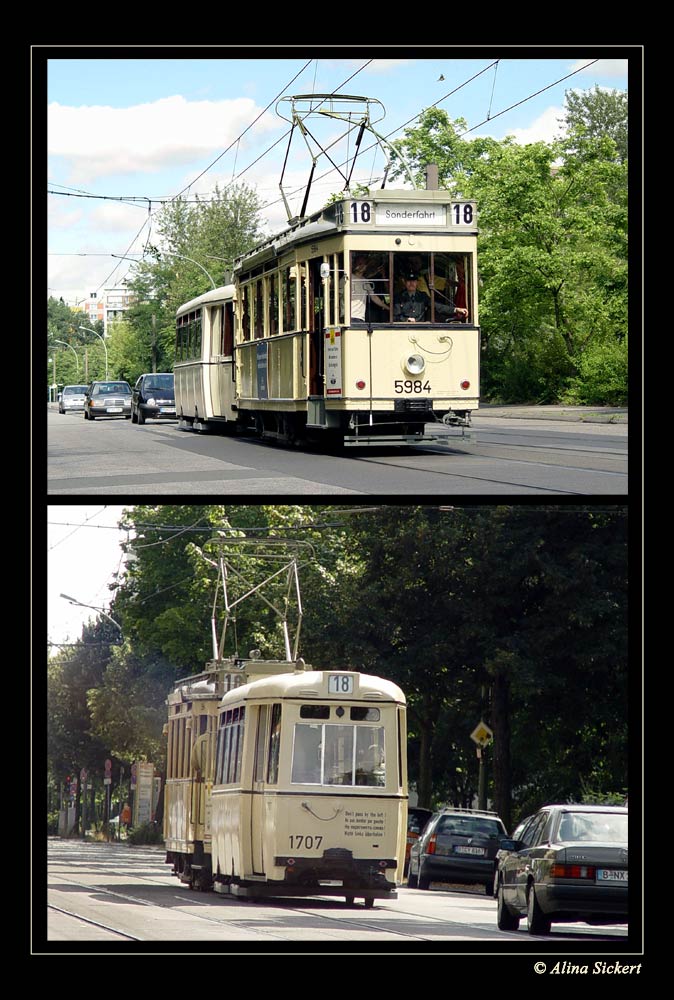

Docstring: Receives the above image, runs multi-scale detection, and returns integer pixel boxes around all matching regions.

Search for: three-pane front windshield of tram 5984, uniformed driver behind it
[350,250,470,324]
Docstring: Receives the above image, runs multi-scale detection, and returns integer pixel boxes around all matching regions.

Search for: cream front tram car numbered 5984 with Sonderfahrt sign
[234,189,480,445]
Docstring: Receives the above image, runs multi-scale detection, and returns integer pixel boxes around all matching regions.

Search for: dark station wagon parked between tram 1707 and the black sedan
[407,807,507,896]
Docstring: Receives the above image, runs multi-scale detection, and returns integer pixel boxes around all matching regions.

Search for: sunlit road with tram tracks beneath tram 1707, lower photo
[43,837,638,948]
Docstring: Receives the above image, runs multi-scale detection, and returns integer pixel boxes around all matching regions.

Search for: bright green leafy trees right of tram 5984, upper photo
[386,88,628,404]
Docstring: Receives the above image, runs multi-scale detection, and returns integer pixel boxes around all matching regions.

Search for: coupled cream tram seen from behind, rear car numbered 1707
[164,659,407,907]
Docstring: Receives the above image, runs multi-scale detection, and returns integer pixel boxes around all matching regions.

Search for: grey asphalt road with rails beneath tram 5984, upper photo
[47,404,628,497]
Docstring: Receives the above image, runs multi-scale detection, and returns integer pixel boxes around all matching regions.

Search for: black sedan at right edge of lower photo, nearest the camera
[496,805,628,934]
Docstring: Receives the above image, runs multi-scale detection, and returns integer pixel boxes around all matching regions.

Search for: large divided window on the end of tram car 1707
[291,723,386,786]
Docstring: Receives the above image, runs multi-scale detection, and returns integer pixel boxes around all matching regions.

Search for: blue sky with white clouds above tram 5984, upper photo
[46,47,627,306]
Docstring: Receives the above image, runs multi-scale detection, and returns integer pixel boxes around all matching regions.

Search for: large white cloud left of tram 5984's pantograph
[48,96,278,184]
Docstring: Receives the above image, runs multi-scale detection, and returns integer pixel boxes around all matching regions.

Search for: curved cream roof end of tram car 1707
[222,670,406,705]
